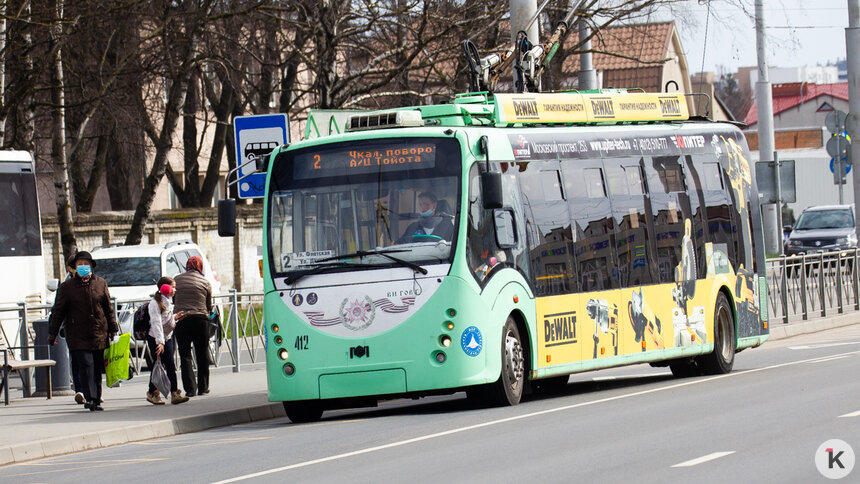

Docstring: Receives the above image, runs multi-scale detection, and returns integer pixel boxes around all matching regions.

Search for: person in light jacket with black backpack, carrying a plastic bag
[144,277,188,405]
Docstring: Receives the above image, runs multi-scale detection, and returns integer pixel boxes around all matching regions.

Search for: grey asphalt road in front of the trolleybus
[0,325,860,484]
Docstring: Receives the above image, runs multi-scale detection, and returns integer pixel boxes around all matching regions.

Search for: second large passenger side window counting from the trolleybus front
[561,160,619,291]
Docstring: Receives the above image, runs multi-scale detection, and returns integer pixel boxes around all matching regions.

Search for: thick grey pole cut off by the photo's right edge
[845,0,860,238]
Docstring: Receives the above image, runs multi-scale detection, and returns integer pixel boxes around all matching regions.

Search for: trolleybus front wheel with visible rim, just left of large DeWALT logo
[486,316,526,407]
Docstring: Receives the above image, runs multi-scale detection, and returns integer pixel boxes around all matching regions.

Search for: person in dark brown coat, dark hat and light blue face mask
[48,251,119,411]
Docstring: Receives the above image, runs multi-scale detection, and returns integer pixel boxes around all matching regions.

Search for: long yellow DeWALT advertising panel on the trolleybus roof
[495,93,689,125]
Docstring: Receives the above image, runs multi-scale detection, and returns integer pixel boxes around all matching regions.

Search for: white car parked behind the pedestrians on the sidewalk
[91,240,224,366]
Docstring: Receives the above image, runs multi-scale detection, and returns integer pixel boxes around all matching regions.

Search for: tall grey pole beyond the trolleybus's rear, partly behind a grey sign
[755,0,782,254]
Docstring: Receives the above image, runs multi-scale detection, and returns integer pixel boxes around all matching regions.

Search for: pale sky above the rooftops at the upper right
[655,0,848,74]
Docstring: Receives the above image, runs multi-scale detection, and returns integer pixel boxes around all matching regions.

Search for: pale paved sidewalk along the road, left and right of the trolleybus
[0,312,860,465]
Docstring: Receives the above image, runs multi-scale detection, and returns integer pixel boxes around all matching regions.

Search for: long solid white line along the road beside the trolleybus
[213,351,860,484]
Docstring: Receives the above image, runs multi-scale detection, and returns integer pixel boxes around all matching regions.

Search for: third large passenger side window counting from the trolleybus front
[603,158,655,287]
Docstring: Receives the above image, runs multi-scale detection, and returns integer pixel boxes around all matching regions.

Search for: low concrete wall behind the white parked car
[42,204,263,292]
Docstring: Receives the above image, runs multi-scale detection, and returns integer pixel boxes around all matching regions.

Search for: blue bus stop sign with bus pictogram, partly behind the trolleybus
[233,113,290,198]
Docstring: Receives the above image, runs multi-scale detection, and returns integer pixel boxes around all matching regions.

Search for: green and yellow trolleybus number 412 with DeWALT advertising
[218,91,768,421]
